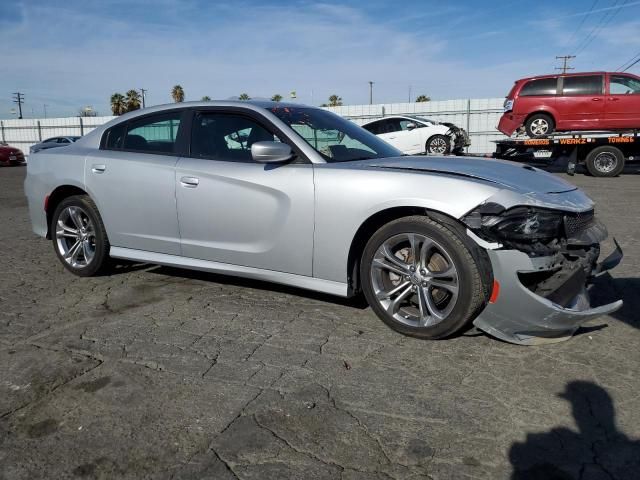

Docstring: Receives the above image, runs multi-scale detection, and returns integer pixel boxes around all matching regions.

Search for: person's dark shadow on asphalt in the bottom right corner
[509,381,640,480]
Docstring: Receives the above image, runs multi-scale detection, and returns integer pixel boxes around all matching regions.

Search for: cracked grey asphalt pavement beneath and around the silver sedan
[0,167,640,480]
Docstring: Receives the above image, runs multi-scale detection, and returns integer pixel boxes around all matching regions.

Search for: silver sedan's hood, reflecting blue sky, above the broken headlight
[366,156,577,194]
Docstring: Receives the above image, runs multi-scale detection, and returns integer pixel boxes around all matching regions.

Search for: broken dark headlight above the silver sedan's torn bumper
[463,205,564,243]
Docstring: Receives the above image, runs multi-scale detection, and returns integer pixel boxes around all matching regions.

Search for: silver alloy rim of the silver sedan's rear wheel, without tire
[56,206,96,269]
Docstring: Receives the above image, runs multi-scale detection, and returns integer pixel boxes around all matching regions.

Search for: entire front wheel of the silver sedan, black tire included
[360,216,486,339]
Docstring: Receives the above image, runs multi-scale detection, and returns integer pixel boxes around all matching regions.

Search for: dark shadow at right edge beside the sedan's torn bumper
[589,272,640,330]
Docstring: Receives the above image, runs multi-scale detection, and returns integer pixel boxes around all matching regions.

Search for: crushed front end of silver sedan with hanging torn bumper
[463,202,622,345]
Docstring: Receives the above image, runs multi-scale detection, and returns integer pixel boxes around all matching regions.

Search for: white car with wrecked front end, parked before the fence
[362,115,471,155]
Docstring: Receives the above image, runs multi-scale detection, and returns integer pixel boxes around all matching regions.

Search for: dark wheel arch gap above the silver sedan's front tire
[347,206,493,301]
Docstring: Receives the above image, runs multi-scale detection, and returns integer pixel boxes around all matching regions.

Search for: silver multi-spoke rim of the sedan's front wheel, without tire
[371,233,459,327]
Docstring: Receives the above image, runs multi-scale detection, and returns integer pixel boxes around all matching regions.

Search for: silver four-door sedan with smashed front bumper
[25,102,622,344]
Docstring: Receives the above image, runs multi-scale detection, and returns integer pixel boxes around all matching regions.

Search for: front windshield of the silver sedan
[268,107,402,162]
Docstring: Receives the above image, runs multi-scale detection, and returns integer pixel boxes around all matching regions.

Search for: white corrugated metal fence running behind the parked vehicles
[0,98,504,154]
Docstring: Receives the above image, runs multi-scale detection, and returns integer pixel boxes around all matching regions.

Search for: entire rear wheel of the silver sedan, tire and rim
[50,195,109,277]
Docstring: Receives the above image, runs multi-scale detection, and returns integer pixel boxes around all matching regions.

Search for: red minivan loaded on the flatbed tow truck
[498,72,640,138]
